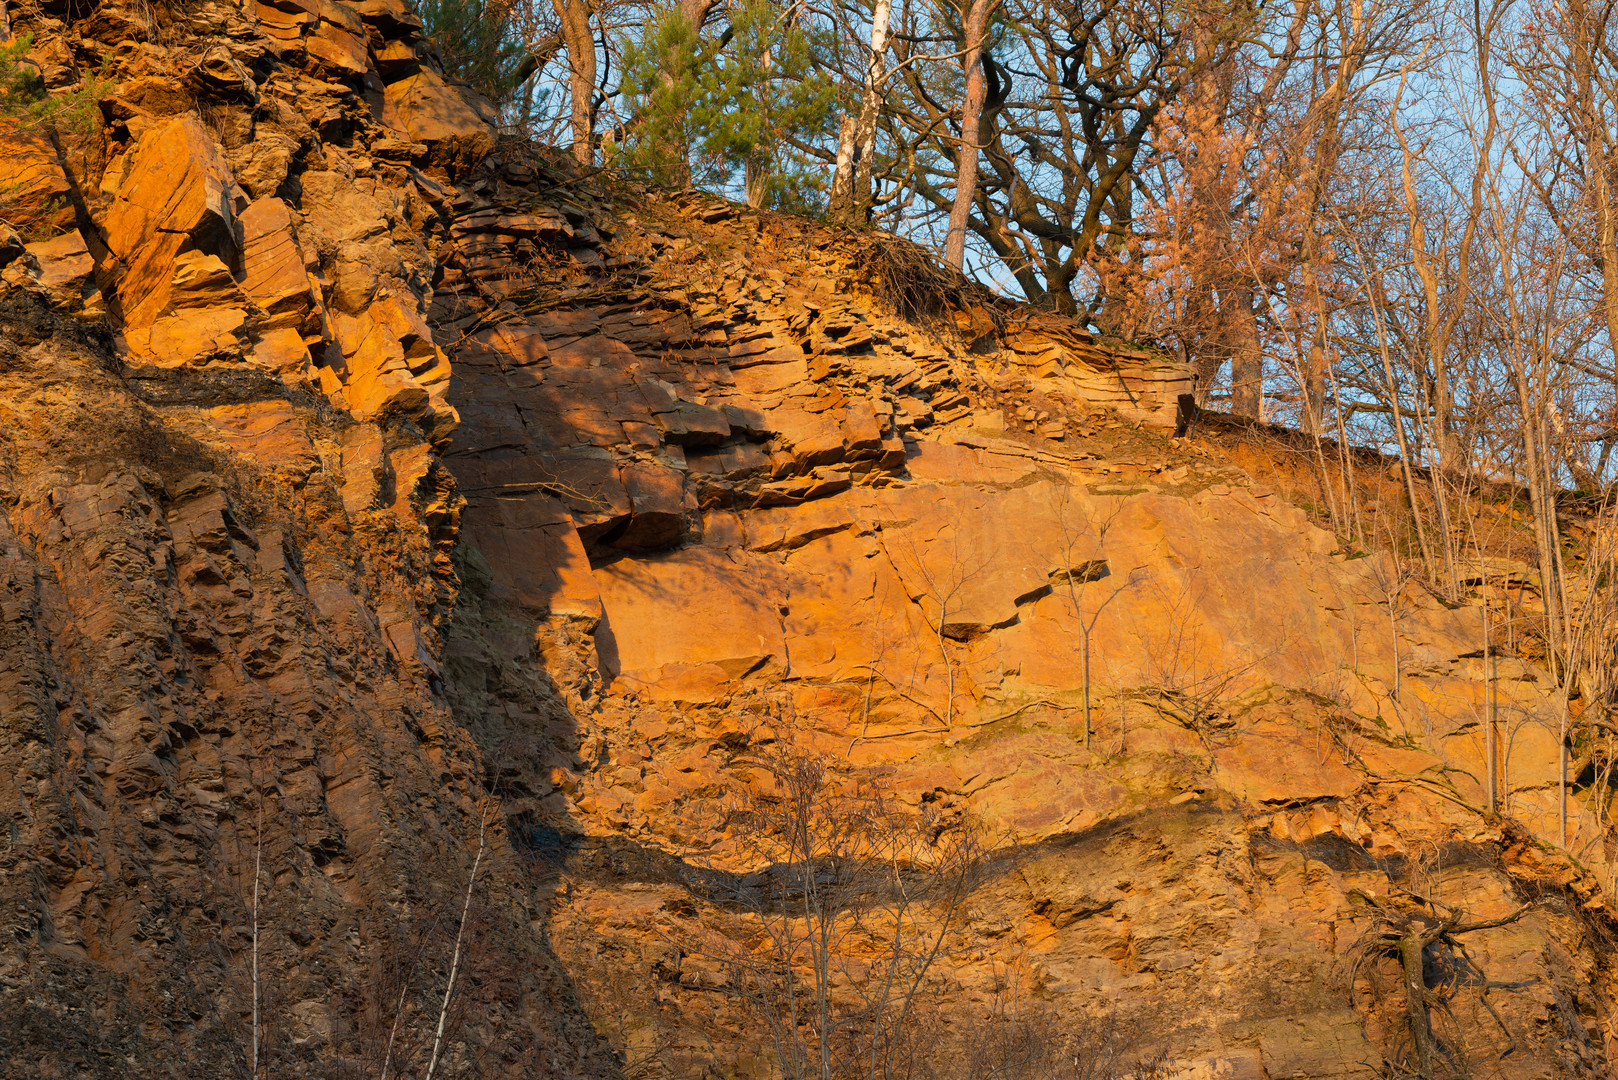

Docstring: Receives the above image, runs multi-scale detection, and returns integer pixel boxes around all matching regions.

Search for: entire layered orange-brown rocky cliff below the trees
[0,0,1615,1080]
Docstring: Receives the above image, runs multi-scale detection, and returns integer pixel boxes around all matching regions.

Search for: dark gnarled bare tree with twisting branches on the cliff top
[885,0,1194,314]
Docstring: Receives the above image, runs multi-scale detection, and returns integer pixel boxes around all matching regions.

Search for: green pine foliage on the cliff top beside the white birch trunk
[610,0,835,210]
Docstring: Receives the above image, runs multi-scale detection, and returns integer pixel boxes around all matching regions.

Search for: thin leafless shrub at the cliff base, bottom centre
[712,750,984,1080]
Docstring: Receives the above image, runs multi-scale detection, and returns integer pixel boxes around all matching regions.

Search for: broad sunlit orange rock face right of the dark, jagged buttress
[438,196,1610,1077]
